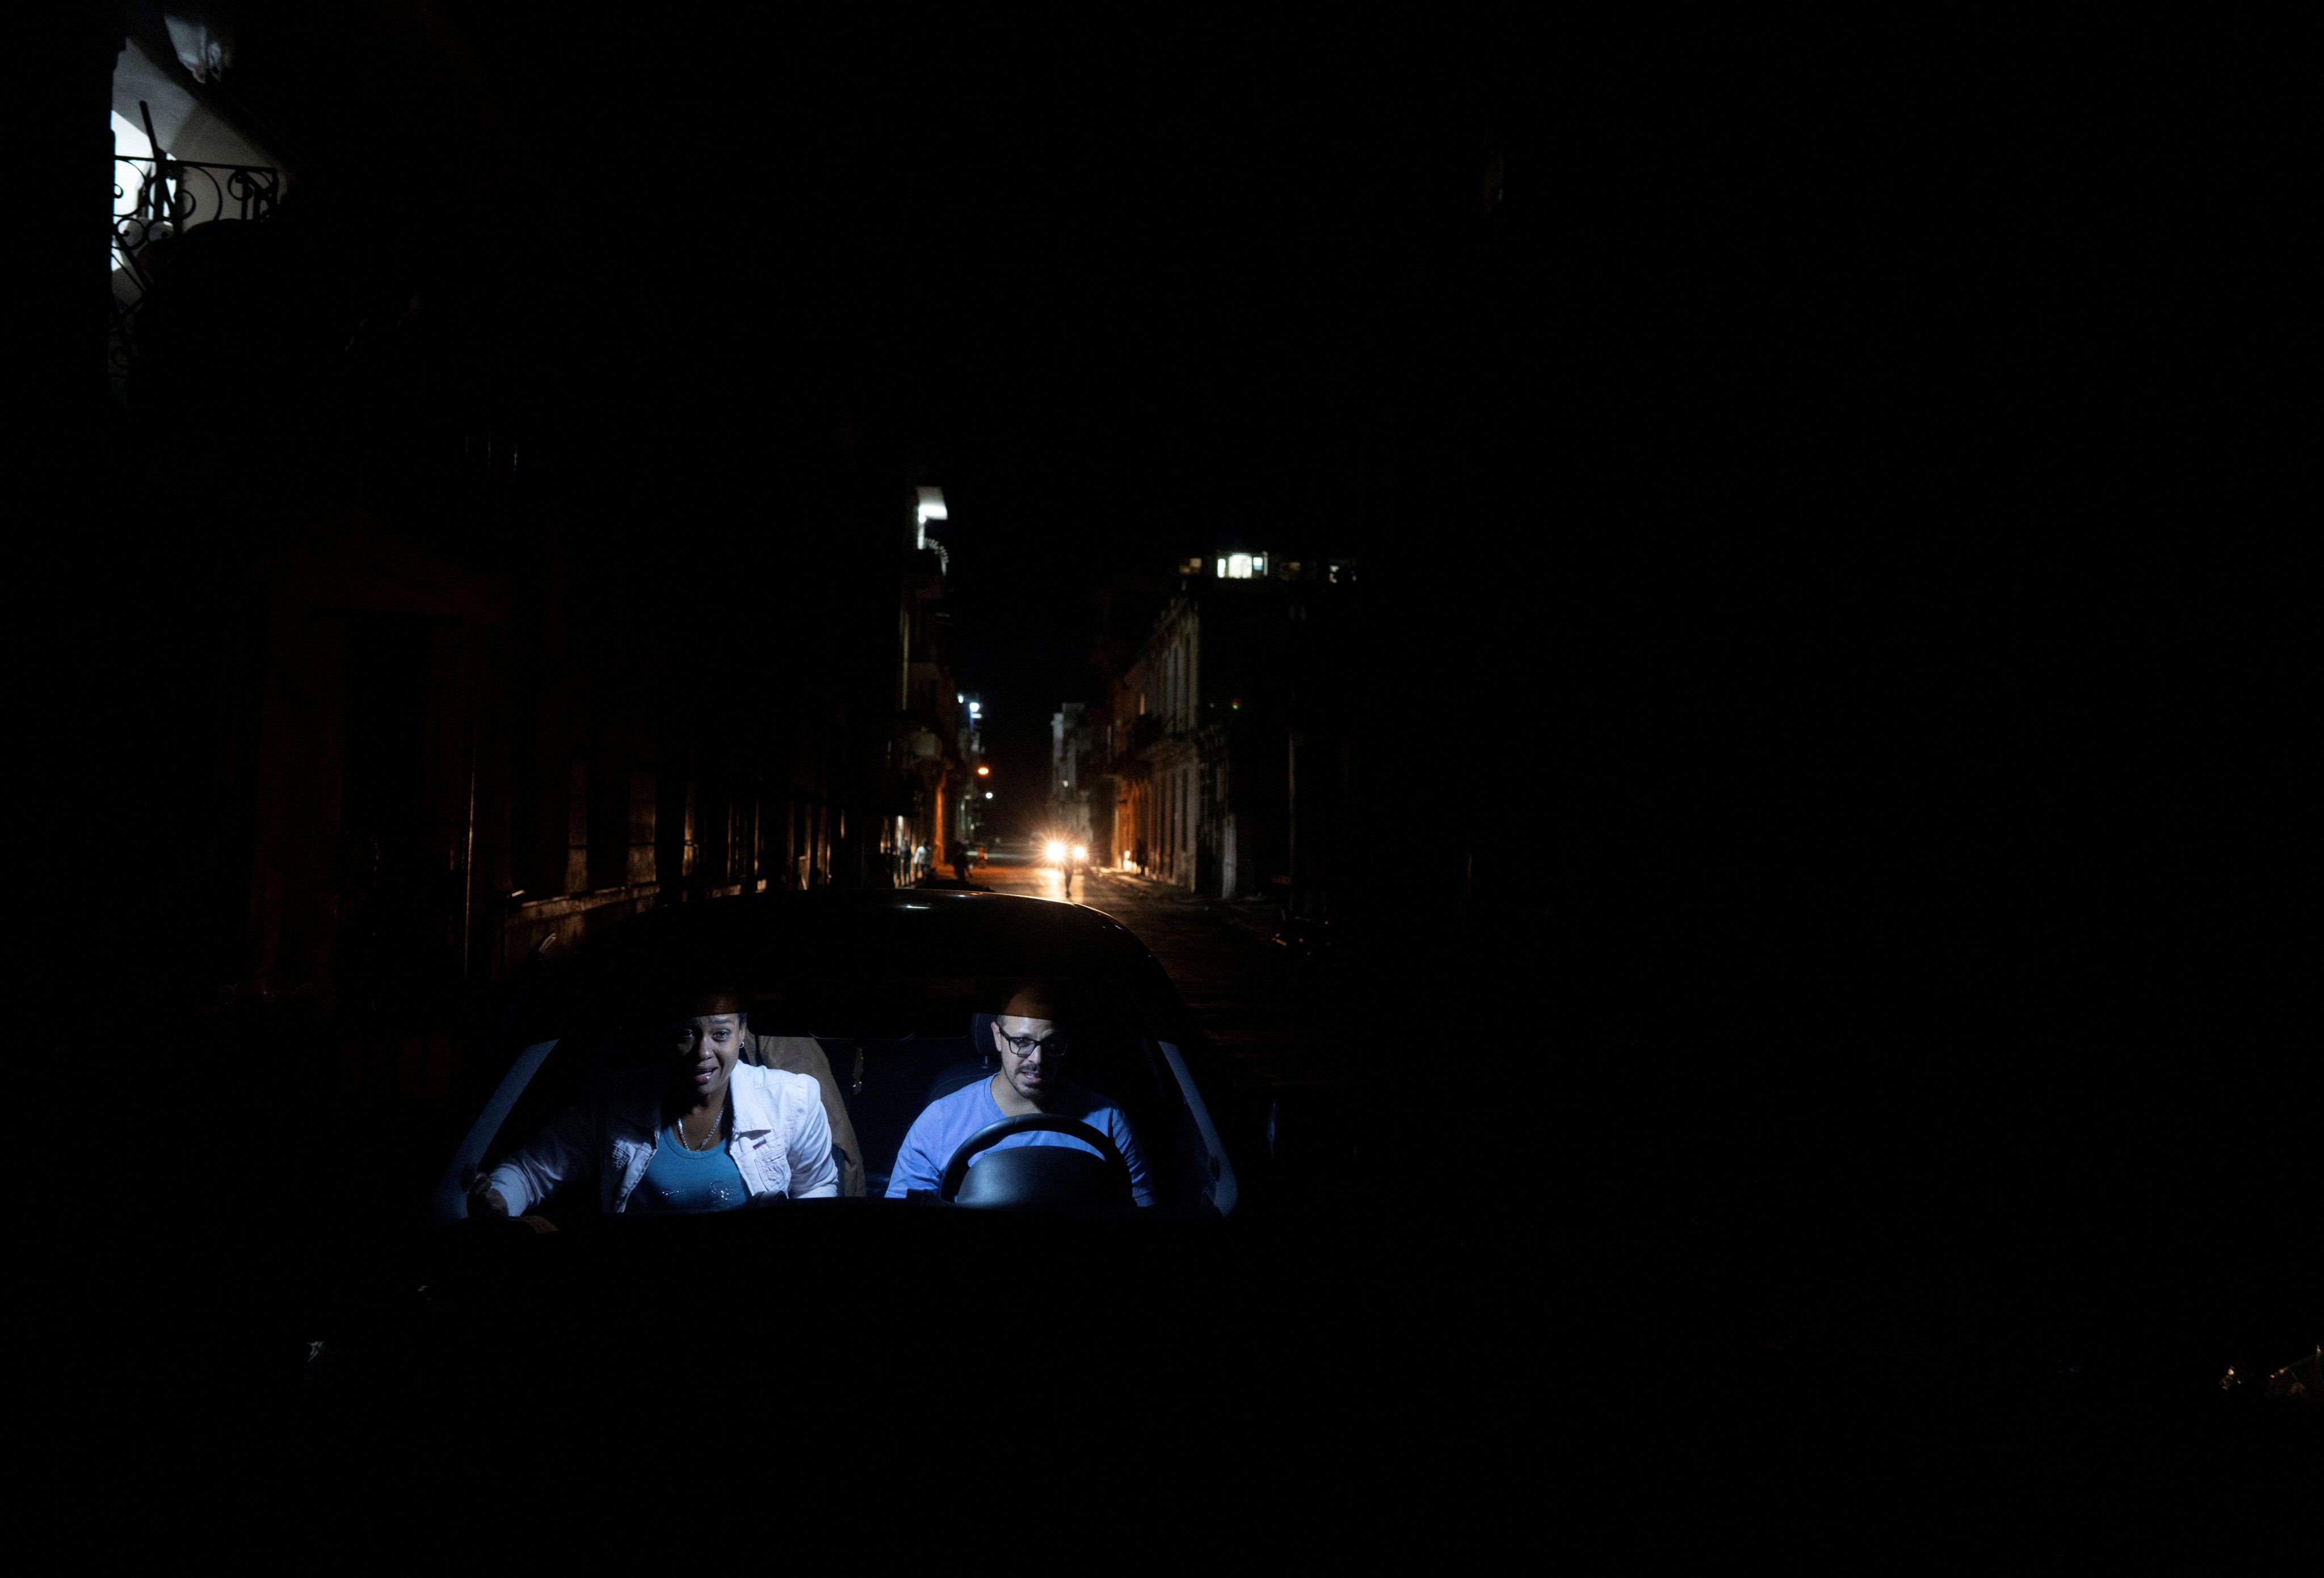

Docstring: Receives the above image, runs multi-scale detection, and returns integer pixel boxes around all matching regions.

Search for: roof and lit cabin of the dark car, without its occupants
[432,890,1241,1224]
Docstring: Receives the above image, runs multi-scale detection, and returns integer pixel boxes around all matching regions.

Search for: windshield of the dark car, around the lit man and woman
[481,965,1232,1220]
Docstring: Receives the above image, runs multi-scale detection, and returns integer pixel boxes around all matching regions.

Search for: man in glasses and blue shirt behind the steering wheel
[888,983,1155,1206]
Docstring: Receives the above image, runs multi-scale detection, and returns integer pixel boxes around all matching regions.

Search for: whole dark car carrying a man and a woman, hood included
[307,888,1280,1413]
